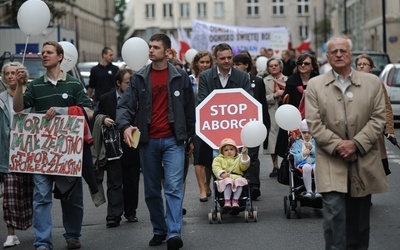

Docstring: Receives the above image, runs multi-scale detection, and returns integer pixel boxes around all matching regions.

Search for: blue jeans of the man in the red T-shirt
[139,137,185,239]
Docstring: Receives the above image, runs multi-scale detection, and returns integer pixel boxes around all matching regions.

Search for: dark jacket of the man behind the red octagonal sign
[197,66,253,103]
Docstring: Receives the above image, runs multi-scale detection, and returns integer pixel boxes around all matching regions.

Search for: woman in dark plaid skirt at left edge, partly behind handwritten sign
[0,62,33,248]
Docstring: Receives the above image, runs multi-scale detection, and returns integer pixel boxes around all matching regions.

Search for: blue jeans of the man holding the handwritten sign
[33,174,83,249]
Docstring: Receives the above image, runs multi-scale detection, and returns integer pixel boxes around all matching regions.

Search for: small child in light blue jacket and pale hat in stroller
[289,119,321,198]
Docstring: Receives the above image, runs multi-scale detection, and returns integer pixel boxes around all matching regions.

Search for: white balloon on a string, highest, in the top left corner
[17,0,50,36]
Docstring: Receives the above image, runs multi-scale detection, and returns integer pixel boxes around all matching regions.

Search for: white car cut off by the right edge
[379,63,400,122]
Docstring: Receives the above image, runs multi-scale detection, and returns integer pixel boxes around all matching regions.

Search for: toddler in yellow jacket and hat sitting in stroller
[212,138,250,212]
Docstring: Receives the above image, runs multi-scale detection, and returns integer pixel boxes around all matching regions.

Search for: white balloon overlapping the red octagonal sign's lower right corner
[240,121,267,148]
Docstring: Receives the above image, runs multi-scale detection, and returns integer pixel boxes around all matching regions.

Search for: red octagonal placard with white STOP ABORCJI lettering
[196,88,262,149]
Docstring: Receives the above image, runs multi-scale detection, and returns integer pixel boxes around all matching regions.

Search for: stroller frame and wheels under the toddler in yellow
[208,176,257,224]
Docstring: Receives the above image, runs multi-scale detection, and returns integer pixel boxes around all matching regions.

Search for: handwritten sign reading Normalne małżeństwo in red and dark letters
[9,113,85,177]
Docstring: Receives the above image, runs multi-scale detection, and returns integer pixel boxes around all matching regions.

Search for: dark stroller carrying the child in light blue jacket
[280,132,322,219]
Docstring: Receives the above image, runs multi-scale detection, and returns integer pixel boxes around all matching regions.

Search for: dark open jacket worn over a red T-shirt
[116,63,195,143]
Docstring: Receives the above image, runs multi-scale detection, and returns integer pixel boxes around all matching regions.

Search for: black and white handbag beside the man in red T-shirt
[101,124,123,161]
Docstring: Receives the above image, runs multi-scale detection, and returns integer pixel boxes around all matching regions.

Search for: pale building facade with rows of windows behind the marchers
[125,0,323,55]
